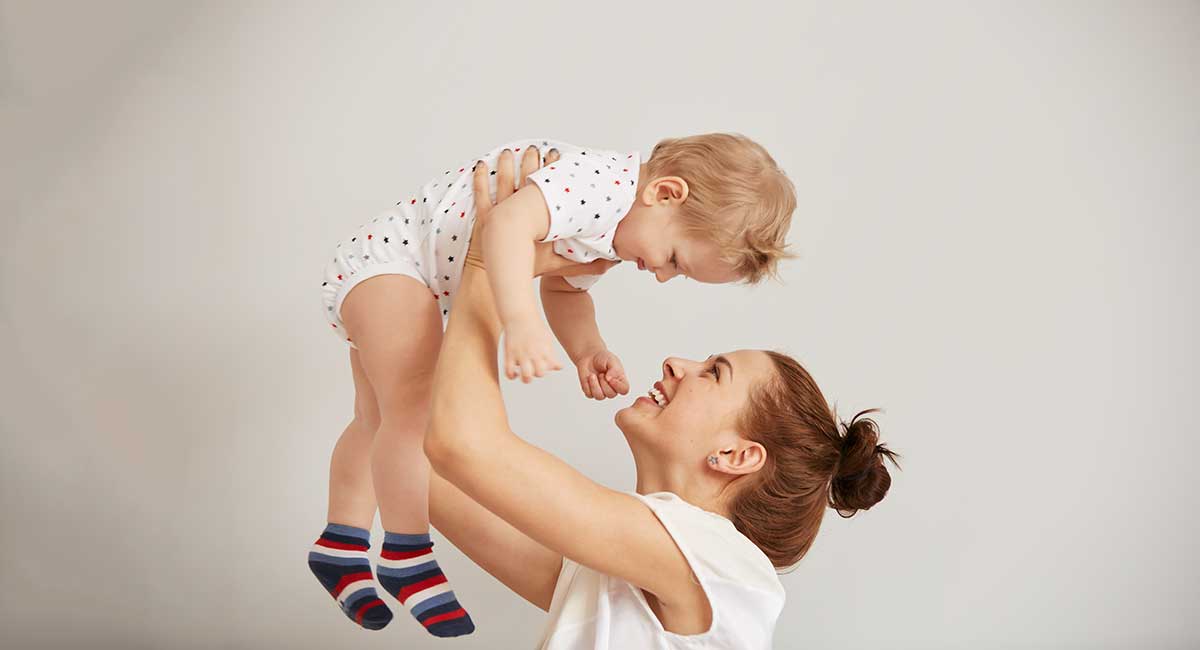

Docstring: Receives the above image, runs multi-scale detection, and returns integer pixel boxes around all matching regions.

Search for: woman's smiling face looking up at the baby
[616,350,775,465]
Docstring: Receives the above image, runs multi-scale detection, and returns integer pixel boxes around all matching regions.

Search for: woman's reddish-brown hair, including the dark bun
[730,350,900,568]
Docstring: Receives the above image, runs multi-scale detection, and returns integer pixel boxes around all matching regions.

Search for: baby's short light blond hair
[646,133,796,284]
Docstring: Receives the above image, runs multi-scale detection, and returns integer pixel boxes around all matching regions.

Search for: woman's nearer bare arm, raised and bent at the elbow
[425,157,703,607]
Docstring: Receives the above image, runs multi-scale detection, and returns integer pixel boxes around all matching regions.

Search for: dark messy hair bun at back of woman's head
[829,409,900,517]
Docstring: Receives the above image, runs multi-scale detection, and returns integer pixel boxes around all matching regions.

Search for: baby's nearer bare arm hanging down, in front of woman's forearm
[480,185,563,384]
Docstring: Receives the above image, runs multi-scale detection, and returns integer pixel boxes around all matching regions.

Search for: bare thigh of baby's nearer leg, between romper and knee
[342,275,442,425]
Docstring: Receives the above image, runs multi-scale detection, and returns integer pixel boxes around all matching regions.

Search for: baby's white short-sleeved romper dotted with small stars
[320,138,641,348]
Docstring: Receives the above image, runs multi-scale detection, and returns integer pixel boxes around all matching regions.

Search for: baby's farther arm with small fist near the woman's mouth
[541,276,629,399]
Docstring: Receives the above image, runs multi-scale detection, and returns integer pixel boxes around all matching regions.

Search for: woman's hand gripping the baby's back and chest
[466,146,619,280]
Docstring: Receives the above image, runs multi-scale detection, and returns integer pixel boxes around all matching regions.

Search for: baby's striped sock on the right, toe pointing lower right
[376,532,475,637]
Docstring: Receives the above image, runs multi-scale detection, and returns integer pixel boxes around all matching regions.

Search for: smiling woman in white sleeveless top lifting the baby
[347,150,892,649]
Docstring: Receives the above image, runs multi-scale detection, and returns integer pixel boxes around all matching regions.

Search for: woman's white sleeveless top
[539,492,785,650]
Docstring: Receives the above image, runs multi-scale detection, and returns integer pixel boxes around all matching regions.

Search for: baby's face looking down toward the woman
[613,207,739,284]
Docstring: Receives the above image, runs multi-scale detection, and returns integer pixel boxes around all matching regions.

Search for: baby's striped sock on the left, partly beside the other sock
[308,524,391,630]
